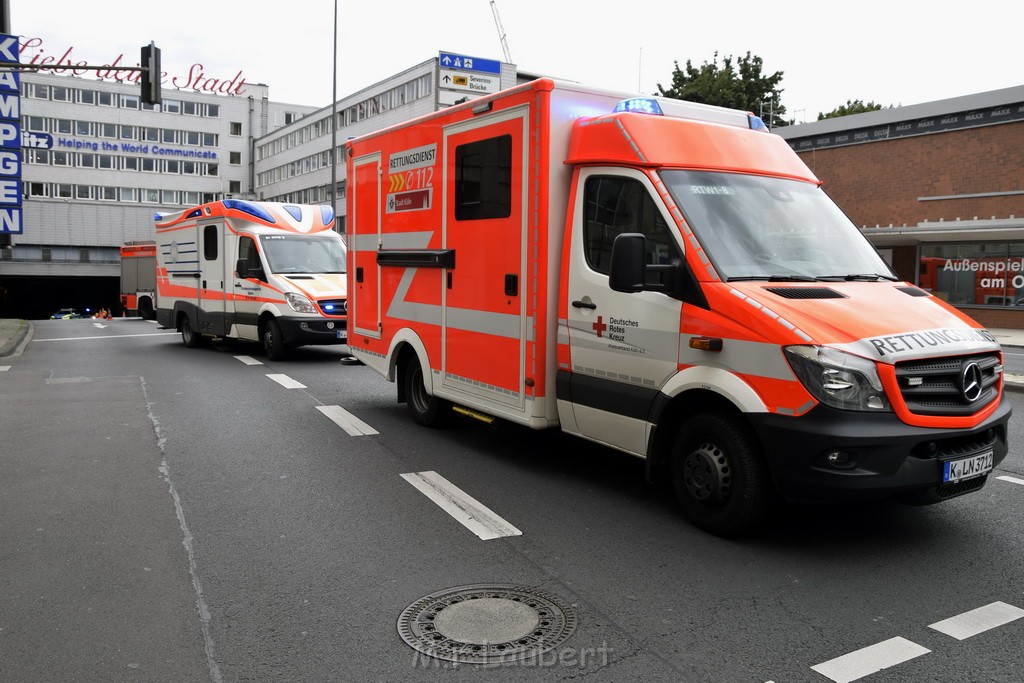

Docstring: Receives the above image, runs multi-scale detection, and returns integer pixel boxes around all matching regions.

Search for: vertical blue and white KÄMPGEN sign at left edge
[0,34,22,234]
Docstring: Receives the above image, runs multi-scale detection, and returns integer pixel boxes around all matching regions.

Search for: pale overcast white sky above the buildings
[10,0,1024,122]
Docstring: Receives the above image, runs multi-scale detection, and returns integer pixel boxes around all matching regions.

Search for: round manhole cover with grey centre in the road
[398,584,577,664]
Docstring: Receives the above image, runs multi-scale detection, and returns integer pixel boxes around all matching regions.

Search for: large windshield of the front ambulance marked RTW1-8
[662,170,898,281]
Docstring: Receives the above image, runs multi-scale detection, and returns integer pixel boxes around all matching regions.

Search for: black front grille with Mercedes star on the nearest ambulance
[896,353,1002,417]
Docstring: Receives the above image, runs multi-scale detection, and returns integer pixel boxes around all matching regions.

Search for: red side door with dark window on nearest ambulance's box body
[441,104,531,413]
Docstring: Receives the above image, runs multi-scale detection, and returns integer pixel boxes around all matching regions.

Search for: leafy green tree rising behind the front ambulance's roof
[657,51,786,127]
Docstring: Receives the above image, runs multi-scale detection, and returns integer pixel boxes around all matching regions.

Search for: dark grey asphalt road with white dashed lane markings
[0,318,1024,683]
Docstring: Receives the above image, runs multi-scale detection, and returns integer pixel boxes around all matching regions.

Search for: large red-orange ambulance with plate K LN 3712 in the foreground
[346,79,1011,535]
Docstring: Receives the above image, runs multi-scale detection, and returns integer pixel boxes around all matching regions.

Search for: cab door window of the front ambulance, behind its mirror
[583,176,682,274]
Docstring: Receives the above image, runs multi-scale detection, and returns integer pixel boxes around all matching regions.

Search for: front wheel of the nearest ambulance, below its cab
[671,413,773,537]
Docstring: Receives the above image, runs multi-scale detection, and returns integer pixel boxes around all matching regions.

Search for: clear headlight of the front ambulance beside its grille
[782,346,892,411]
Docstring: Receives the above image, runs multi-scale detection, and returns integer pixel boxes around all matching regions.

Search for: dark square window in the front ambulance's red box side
[455,135,512,220]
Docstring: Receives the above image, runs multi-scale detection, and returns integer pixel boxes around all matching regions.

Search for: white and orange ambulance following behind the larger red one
[155,199,347,360]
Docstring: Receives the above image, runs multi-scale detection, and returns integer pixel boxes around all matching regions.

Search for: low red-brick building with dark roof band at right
[773,86,1024,329]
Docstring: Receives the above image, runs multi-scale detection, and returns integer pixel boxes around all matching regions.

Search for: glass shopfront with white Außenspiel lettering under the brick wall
[918,242,1024,310]
